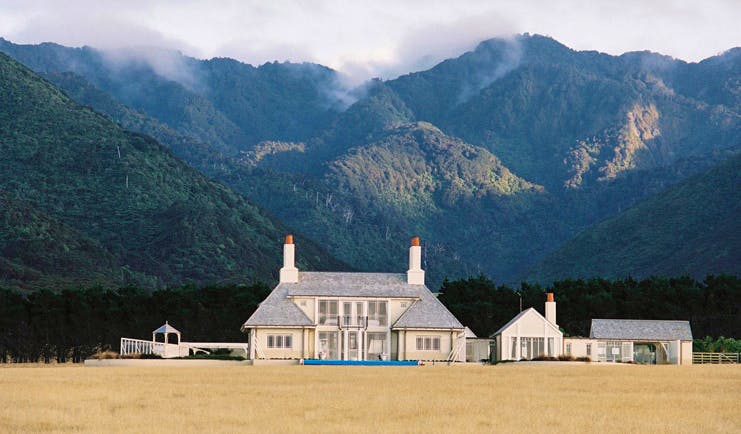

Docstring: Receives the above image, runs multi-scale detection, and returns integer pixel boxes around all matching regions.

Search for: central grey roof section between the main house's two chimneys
[288,272,423,298]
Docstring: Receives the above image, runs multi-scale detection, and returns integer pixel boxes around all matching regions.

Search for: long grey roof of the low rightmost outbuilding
[589,319,692,341]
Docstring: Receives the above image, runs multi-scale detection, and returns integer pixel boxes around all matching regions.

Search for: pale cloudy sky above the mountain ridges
[0,0,741,78]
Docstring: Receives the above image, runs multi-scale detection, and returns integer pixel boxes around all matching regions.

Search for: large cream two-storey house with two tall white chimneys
[242,235,466,361]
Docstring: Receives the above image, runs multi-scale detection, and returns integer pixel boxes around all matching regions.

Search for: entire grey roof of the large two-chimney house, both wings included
[242,272,463,329]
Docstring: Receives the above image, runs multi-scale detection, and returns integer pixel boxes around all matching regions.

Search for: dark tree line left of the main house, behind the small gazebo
[0,283,270,363]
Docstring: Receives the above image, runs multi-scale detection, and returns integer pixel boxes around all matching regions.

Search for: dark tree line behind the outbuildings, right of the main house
[439,275,741,338]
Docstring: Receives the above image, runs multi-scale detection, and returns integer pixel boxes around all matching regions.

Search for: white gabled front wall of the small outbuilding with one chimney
[497,310,563,360]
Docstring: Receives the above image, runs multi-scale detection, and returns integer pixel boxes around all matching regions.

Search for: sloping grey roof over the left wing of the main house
[242,283,314,329]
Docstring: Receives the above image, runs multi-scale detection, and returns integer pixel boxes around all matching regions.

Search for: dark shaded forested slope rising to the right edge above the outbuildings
[529,155,741,282]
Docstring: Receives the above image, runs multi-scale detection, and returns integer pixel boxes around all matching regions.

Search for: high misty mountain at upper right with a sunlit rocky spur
[388,35,741,191]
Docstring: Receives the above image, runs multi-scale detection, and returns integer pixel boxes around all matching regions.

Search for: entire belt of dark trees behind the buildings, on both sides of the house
[0,275,741,363]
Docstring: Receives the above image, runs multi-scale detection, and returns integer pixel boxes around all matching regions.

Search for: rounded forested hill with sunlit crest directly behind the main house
[233,123,573,287]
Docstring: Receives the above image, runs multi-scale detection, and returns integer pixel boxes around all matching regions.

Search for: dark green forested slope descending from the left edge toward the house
[0,54,343,288]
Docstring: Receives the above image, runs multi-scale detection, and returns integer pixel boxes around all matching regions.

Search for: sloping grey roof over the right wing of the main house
[392,285,463,329]
